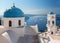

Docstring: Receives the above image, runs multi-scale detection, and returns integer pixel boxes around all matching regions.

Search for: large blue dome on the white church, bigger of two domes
[4,6,24,18]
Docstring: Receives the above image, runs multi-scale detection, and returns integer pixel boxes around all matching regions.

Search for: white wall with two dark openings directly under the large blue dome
[2,17,25,27]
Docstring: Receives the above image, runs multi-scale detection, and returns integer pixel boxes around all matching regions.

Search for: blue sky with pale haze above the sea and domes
[0,0,60,15]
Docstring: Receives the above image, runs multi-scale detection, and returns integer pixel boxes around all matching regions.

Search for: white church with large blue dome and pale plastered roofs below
[0,5,38,43]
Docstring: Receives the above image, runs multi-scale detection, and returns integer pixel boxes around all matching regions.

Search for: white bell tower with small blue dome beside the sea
[47,12,56,34]
